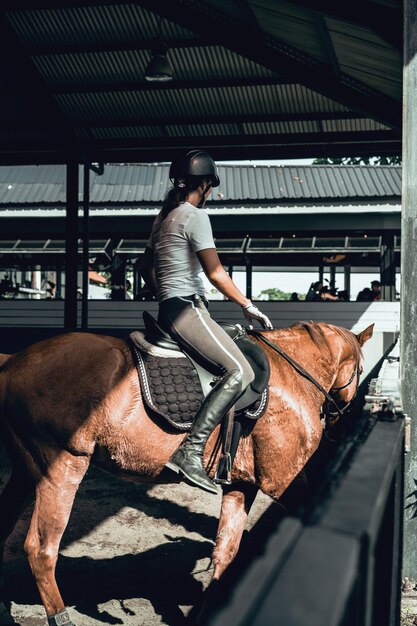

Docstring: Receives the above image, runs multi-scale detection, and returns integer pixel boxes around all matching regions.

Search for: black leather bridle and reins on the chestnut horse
[247,329,360,426]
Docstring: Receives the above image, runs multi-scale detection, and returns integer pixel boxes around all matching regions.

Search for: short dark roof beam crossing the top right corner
[278,0,403,52]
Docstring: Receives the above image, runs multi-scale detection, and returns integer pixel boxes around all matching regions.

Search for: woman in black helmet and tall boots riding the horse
[141,150,272,493]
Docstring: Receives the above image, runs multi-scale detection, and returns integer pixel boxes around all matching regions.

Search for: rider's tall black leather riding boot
[166,370,242,493]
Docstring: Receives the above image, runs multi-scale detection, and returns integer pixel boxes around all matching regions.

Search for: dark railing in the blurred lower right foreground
[205,342,404,626]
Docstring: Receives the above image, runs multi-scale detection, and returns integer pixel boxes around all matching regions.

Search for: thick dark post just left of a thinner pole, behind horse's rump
[64,161,79,329]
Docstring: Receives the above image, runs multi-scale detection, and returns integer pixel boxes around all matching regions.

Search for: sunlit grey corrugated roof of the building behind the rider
[0,164,401,206]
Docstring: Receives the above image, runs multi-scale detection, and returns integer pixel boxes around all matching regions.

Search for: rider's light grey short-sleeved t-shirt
[147,202,216,302]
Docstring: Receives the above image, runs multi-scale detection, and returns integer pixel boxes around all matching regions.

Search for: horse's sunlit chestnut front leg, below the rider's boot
[213,483,258,581]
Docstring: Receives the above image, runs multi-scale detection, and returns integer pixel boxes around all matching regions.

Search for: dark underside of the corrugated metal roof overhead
[0,0,402,163]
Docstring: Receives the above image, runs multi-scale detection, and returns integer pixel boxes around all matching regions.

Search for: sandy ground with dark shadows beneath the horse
[0,438,270,626]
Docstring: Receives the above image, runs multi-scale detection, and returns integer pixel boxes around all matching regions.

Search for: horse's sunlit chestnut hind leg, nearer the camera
[25,451,90,626]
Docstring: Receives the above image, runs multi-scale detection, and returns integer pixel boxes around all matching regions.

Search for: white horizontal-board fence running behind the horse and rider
[0,300,400,374]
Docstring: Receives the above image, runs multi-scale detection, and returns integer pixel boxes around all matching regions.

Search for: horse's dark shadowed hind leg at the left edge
[0,469,34,626]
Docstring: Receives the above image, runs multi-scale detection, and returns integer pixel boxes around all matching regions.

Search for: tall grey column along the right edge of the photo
[400,0,417,580]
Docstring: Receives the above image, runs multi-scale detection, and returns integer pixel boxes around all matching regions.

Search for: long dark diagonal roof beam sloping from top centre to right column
[137,0,402,128]
